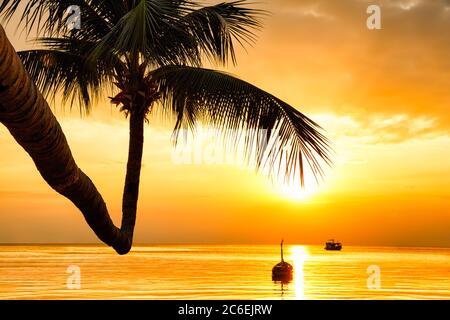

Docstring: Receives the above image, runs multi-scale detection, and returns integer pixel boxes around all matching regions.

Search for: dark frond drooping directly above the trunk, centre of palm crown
[91,0,198,65]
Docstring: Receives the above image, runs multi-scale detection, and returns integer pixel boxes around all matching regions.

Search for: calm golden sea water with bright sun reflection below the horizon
[0,245,450,299]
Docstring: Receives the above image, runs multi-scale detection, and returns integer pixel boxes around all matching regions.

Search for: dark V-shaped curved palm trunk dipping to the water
[0,26,143,254]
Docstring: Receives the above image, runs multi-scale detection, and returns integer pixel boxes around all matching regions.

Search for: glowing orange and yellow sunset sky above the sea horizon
[0,0,450,247]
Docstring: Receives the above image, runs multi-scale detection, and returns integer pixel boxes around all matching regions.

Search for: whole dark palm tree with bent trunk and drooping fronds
[0,0,329,254]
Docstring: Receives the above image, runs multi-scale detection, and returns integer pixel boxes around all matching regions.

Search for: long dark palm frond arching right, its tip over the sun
[150,66,330,184]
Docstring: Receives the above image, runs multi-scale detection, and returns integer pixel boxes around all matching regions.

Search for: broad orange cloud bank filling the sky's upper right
[227,0,450,136]
